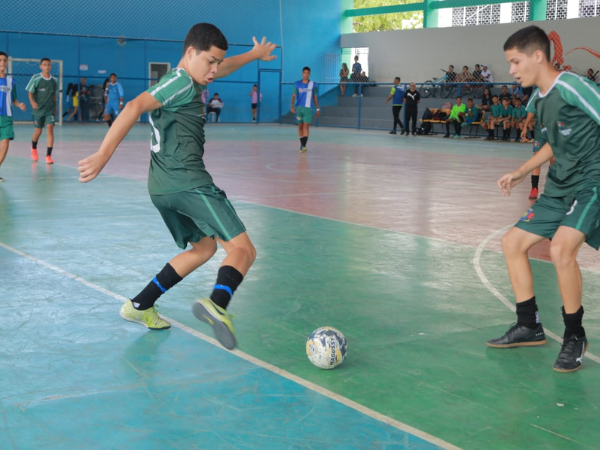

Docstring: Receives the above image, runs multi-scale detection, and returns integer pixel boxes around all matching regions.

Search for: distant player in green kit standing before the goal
[25,58,58,164]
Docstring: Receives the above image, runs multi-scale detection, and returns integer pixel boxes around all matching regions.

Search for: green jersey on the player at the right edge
[528,72,600,197]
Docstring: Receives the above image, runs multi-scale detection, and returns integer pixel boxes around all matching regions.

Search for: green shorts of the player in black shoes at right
[515,186,600,250]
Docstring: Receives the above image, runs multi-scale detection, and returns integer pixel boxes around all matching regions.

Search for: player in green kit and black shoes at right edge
[488,26,600,372]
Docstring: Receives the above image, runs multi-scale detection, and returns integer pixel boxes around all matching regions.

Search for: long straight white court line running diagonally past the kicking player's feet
[0,242,460,450]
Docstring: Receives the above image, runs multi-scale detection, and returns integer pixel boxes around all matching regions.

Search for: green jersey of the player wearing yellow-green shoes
[147,68,213,195]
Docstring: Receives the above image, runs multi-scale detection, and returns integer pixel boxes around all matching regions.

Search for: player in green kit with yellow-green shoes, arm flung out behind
[79,23,276,349]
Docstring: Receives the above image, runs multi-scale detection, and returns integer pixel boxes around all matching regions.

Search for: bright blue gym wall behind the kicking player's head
[0,0,341,122]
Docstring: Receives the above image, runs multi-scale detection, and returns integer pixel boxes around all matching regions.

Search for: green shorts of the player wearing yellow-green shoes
[150,185,246,248]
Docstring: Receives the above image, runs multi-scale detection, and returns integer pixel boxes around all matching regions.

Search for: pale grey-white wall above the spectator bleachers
[341,17,600,82]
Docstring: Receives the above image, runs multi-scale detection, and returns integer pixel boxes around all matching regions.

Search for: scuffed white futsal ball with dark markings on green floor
[306,327,348,369]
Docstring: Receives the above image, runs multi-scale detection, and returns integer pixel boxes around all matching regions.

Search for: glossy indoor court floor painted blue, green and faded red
[0,124,600,450]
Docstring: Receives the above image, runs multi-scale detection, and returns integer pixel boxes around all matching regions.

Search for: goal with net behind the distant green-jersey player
[7,58,63,125]
